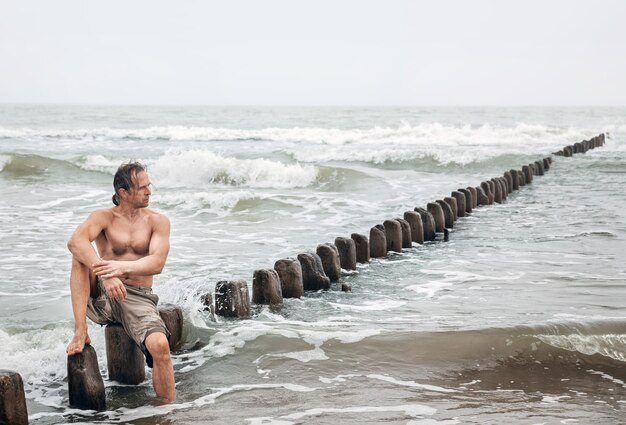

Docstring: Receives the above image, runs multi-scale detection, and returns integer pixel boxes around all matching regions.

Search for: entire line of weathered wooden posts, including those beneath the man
[0,134,605,425]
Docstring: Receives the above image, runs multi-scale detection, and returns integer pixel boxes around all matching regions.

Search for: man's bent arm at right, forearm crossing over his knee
[93,214,170,279]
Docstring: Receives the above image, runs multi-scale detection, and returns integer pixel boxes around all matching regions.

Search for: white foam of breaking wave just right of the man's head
[150,149,318,189]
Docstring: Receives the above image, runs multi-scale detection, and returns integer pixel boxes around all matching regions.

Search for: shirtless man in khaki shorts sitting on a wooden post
[66,162,174,401]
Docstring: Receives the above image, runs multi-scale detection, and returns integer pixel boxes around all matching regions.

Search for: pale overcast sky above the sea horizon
[0,0,626,105]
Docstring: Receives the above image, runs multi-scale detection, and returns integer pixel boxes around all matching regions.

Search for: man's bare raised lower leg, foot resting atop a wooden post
[65,257,96,356]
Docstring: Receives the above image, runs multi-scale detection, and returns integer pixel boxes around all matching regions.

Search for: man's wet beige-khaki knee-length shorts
[87,278,170,354]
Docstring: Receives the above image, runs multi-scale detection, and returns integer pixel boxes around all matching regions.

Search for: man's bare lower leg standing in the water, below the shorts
[145,332,175,402]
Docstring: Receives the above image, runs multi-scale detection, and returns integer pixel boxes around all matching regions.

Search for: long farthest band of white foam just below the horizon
[0,122,596,146]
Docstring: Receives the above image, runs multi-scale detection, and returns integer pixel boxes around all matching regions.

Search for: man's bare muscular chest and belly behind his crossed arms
[95,208,158,287]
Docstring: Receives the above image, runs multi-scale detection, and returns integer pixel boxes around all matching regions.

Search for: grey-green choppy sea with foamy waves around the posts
[0,105,626,425]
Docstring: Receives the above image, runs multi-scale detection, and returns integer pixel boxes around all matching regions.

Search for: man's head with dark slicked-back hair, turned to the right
[113,162,151,208]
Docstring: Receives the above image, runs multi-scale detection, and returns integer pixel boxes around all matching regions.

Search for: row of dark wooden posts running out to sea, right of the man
[210,133,606,318]
